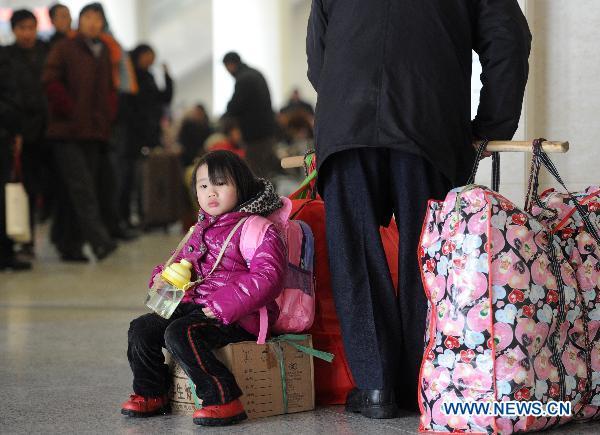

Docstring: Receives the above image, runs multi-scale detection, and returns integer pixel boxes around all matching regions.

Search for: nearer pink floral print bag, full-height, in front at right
[419,144,591,434]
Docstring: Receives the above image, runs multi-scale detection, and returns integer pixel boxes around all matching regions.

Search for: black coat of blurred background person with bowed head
[226,64,275,142]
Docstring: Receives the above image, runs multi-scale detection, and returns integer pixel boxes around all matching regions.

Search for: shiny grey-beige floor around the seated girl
[0,228,600,435]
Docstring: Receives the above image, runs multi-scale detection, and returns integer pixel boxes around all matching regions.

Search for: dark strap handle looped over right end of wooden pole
[525,139,600,245]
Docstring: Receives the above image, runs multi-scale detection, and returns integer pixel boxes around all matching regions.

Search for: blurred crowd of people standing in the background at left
[0,3,314,271]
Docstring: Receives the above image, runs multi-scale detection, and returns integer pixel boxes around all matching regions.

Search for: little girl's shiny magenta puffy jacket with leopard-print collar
[150,181,287,335]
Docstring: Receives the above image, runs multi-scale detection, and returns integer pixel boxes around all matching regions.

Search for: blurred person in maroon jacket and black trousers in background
[43,4,116,261]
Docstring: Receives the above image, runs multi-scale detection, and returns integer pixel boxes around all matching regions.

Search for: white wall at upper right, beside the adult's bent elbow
[527,0,600,190]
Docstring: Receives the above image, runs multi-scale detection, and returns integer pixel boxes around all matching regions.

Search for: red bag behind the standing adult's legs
[290,155,398,405]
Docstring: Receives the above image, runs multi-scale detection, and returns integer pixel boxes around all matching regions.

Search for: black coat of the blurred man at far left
[5,40,48,143]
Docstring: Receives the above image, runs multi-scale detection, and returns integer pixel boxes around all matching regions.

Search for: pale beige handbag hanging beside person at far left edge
[4,147,31,243]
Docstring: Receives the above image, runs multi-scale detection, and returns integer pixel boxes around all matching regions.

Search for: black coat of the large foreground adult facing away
[306,0,531,185]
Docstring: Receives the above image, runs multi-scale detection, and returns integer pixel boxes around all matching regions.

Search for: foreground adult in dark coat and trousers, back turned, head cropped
[307,0,531,418]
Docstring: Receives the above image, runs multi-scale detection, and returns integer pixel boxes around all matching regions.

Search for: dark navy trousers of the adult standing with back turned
[319,148,451,409]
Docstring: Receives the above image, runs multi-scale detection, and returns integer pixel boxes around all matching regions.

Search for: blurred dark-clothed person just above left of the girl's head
[177,104,212,167]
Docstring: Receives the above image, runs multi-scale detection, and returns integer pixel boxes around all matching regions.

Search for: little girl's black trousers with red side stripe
[127,304,256,406]
